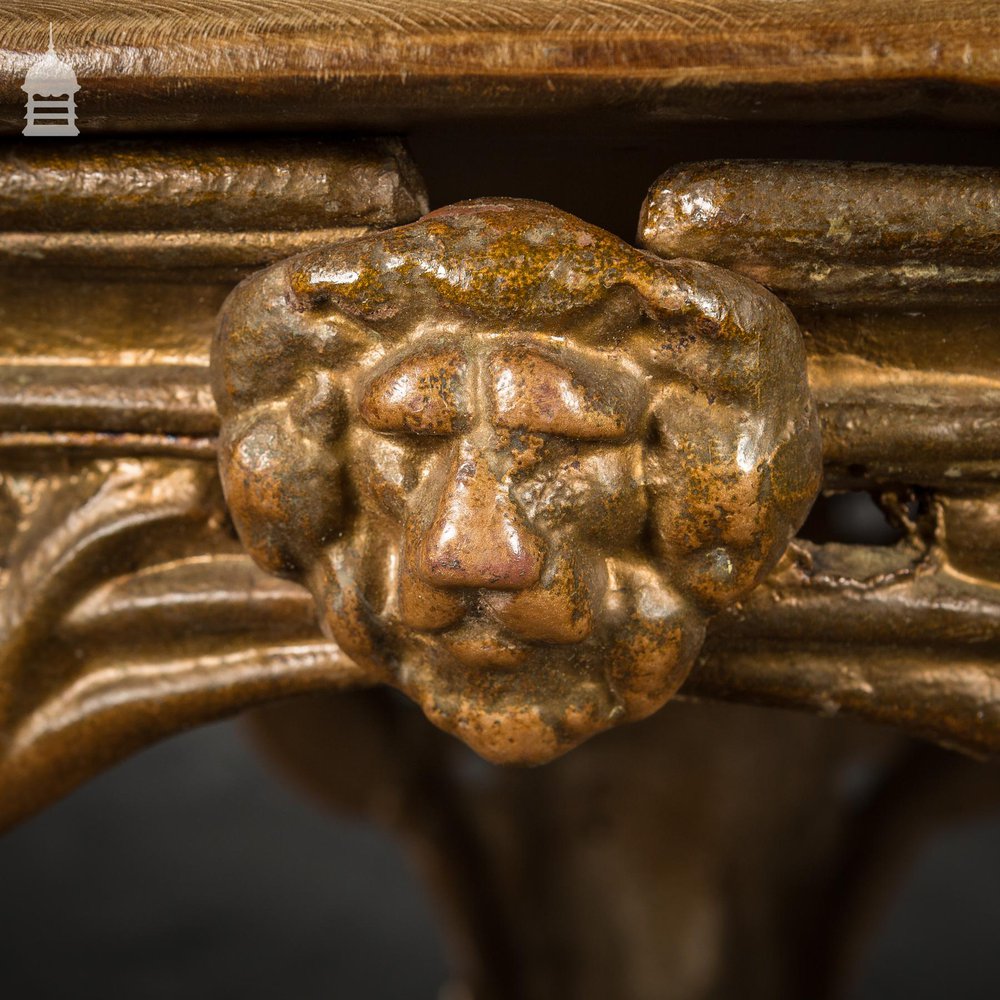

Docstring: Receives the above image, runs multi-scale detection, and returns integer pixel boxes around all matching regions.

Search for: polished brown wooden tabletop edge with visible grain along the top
[0,0,1000,133]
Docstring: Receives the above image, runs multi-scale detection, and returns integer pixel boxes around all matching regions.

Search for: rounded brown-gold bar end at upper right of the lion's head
[639,160,1000,312]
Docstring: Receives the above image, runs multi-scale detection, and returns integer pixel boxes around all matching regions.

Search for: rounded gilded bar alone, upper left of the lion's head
[0,138,427,231]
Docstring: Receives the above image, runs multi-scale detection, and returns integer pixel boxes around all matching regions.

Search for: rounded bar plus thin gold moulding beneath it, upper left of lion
[0,138,427,278]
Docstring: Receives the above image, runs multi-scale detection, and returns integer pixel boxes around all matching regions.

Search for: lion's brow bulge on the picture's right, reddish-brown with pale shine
[492,352,630,441]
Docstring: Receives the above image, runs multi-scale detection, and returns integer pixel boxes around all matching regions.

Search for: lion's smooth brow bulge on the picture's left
[359,353,465,435]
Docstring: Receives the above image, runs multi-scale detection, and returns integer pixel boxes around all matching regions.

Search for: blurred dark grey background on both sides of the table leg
[0,722,1000,1000]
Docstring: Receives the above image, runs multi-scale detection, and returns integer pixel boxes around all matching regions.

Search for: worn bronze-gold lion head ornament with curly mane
[213,200,820,763]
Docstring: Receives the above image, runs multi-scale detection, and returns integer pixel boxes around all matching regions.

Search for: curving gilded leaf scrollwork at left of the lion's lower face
[0,454,364,827]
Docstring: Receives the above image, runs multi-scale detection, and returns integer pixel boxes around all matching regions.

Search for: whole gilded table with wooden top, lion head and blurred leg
[0,17,1000,1000]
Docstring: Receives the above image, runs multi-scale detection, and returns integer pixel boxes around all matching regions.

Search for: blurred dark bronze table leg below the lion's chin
[253,691,1000,1000]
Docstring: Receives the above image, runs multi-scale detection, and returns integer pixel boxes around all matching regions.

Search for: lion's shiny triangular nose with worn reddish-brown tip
[419,444,543,590]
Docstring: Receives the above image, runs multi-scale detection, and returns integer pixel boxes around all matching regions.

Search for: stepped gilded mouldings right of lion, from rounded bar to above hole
[639,161,1000,493]
